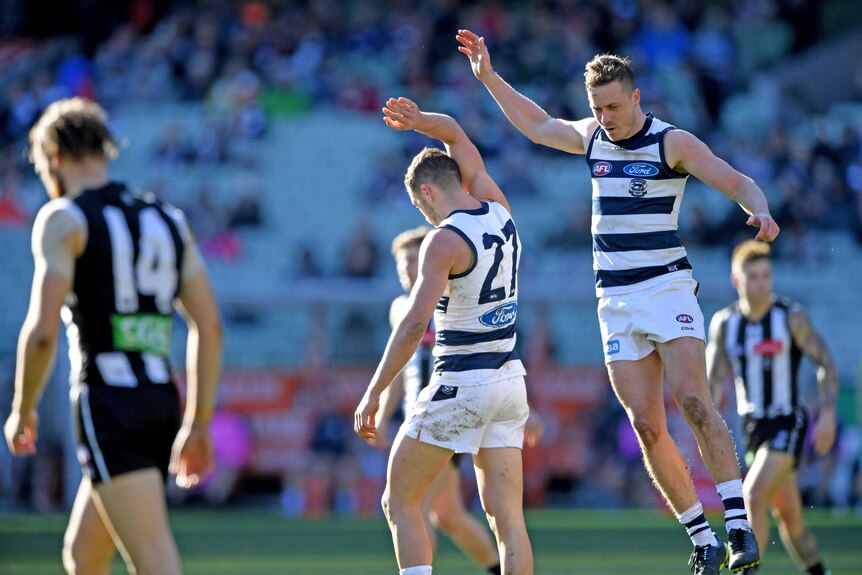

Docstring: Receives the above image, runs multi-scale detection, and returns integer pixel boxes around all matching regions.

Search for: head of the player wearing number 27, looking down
[404,148,464,226]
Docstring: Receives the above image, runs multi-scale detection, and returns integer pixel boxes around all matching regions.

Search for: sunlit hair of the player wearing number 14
[30,98,118,176]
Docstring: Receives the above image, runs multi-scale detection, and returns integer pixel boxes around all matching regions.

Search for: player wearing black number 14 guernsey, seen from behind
[4,98,222,575]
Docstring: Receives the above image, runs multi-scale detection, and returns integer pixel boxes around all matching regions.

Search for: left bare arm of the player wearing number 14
[4,205,86,455]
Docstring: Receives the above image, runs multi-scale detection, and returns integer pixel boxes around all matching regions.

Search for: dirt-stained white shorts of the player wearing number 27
[401,376,530,455]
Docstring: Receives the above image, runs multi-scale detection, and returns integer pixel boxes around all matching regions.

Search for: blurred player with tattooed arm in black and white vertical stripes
[707,240,838,575]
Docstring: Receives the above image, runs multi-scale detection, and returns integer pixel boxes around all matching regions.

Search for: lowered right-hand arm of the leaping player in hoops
[665,130,781,242]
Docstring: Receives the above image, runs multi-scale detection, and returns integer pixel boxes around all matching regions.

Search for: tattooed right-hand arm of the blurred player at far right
[788,306,838,455]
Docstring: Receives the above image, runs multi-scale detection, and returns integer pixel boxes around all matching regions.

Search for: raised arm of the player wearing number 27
[383,98,511,211]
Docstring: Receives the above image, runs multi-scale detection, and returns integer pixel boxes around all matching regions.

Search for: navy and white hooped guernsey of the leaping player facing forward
[586,114,691,296]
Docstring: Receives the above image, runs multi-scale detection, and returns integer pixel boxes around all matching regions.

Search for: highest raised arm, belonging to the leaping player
[456,30,598,154]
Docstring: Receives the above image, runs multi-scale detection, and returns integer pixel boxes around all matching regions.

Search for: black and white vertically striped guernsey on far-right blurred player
[718,299,802,419]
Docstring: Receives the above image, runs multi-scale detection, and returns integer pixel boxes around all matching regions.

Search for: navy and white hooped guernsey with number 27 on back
[432,202,526,386]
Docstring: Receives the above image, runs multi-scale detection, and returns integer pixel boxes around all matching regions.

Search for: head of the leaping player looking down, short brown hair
[584,54,643,141]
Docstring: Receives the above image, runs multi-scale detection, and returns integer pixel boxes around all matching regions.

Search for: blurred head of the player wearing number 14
[30,98,118,198]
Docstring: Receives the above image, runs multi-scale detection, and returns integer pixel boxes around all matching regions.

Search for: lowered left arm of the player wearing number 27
[354,229,473,441]
